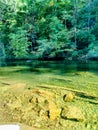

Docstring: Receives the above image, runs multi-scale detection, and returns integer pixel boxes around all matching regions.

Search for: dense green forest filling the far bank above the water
[0,0,98,59]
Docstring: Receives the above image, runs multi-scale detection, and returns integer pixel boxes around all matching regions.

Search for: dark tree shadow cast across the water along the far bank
[0,60,98,75]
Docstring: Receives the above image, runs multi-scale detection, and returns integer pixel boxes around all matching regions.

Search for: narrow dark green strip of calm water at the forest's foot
[0,60,98,73]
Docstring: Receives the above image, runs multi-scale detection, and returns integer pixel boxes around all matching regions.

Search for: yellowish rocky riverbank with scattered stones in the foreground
[0,83,98,130]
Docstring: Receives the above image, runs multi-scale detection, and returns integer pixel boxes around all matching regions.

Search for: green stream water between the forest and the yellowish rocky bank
[0,61,98,94]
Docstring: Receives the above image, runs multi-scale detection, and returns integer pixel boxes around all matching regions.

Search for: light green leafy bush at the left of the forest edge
[9,28,30,58]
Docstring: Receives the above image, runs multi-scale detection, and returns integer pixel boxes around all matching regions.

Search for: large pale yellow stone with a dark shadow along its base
[61,106,84,122]
